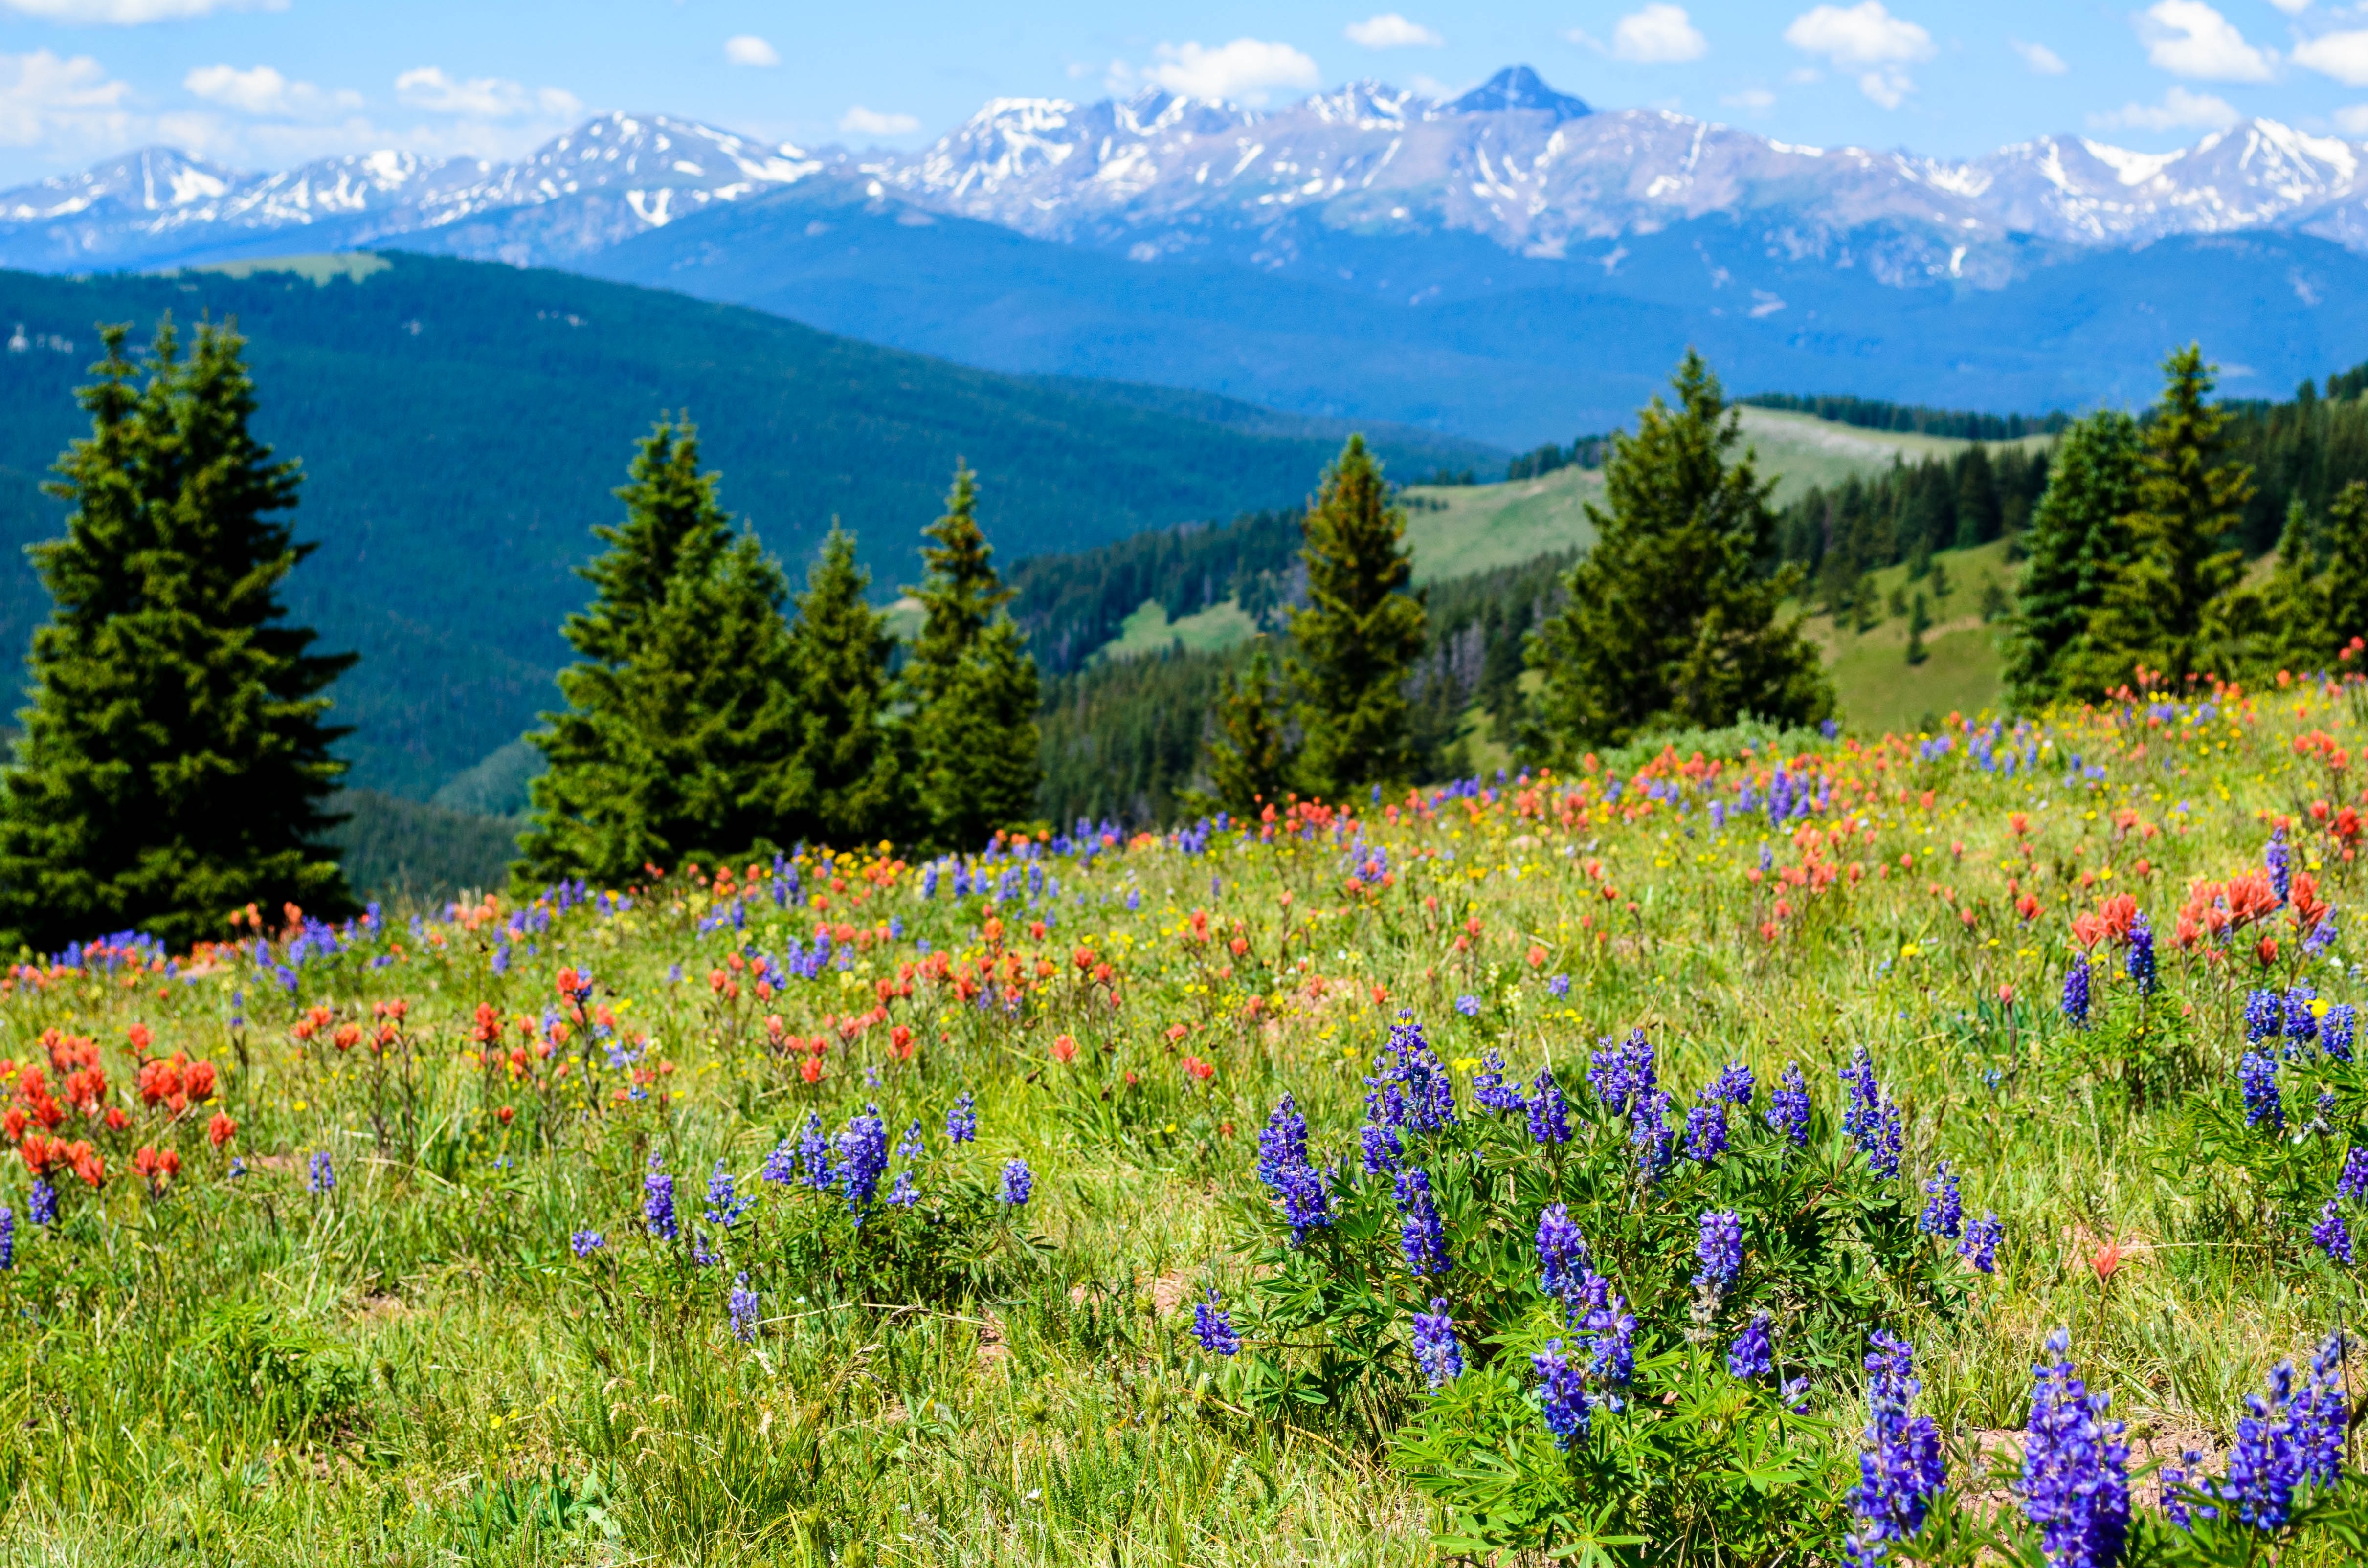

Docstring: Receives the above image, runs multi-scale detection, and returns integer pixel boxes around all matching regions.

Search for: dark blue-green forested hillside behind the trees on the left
[0,256,1504,796]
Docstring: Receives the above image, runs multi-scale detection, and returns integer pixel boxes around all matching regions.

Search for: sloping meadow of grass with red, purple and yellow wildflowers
[14,682,2368,1568]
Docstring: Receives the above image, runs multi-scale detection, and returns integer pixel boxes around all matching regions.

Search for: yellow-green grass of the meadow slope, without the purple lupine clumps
[0,692,2368,1568]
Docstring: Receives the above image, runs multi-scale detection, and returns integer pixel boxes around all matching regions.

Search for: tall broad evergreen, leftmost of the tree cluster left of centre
[516,419,798,886]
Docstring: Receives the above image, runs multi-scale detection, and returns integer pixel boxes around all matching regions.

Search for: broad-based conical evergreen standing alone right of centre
[1530,351,1837,763]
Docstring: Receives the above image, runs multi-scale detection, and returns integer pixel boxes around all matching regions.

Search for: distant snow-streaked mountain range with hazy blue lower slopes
[0,66,2368,445]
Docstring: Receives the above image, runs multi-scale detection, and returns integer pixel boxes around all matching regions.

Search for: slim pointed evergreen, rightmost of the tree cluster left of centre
[905,466,1044,850]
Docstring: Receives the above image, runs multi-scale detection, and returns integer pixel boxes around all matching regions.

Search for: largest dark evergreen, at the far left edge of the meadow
[0,320,353,950]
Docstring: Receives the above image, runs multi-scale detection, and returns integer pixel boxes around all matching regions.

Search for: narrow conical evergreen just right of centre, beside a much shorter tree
[1291,436,1426,800]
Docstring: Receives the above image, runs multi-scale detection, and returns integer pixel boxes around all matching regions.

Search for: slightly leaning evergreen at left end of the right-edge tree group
[2006,410,2141,708]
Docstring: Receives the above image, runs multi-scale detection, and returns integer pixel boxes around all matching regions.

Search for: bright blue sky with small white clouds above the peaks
[0,0,2368,182]
